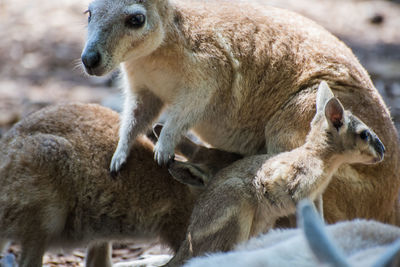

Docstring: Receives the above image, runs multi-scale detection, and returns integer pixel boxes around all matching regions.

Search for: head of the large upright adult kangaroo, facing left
[82,0,166,76]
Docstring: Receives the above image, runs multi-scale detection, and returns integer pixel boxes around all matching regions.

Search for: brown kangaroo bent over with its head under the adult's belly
[0,104,239,267]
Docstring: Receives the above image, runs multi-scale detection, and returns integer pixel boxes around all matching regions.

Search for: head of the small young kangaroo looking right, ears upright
[307,82,385,164]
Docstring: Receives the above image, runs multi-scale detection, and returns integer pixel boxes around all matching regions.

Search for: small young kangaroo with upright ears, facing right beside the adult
[165,82,385,266]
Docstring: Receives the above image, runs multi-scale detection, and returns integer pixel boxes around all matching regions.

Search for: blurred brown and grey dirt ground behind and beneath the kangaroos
[0,0,400,266]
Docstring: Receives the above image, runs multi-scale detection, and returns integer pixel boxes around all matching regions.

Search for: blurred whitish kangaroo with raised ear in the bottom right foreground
[185,200,400,267]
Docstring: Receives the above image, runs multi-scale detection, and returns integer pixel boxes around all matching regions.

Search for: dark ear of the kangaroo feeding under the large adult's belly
[168,161,210,186]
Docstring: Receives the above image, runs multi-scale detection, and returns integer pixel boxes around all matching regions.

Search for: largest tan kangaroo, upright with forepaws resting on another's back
[82,0,400,225]
